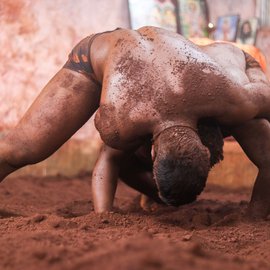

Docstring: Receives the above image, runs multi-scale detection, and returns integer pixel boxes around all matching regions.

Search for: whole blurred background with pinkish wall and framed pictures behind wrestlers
[0,0,270,185]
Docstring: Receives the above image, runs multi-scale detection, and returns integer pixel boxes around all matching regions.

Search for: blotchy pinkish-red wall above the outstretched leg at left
[0,0,129,138]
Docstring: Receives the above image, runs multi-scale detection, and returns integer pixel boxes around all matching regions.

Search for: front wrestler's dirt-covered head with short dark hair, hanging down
[153,126,210,206]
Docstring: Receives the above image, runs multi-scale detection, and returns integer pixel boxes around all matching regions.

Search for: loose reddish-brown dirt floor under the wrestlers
[0,177,270,270]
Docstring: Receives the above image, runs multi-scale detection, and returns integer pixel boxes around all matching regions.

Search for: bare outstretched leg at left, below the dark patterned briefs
[0,69,100,181]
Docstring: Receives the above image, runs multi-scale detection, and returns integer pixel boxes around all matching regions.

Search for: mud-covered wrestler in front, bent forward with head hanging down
[0,27,270,217]
